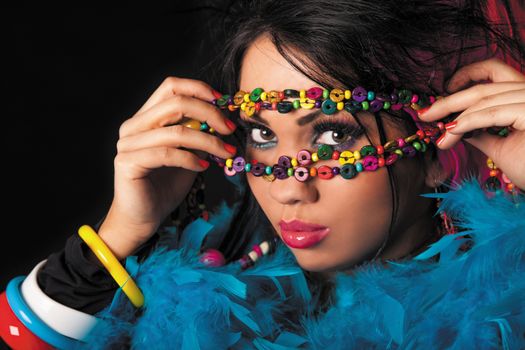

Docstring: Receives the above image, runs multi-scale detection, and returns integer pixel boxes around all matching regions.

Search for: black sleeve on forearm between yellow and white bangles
[37,223,159,315]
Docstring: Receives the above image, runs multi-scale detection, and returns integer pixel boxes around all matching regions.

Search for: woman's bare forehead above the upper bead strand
[240,35,318,92]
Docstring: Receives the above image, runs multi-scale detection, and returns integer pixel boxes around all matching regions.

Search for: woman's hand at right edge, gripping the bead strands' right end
[419,59,525,189]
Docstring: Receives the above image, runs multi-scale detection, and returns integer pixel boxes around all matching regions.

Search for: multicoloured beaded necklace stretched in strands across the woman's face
[192,86,520,269]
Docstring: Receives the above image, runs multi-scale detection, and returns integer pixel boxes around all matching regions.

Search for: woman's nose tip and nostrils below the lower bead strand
[270,172,319,205]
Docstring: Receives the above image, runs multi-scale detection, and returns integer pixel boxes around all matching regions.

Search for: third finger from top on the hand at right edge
[448,103,525,135]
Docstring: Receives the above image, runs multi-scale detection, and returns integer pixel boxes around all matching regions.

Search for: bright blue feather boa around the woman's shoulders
[74,180,525,350]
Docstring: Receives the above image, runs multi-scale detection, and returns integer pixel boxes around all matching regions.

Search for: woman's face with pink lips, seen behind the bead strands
[240,36,438,271]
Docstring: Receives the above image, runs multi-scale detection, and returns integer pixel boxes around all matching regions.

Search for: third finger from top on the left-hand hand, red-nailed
[117,124,236,158]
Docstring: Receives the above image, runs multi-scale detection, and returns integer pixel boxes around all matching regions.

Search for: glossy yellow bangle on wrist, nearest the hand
[78,225,144,307]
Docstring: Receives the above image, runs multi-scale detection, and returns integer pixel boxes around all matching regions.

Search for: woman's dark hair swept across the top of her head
[185,0,525,312]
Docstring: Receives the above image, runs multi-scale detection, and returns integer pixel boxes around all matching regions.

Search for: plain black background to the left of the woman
[0,1,233,291]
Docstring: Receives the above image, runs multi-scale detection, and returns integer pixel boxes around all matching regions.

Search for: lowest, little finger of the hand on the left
[115,147,209,179]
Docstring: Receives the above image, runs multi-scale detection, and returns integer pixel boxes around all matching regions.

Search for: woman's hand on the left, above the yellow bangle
[99,77,235,259]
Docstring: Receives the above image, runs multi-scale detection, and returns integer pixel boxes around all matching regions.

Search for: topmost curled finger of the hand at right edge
[447,58,525,92]
